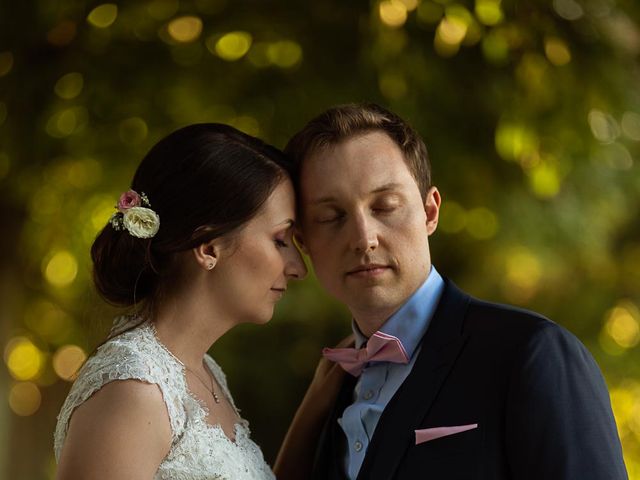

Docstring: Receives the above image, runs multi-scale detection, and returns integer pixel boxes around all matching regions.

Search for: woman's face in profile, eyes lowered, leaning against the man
[214,179,307,323]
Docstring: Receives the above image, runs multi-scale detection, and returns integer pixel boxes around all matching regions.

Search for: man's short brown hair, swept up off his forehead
[284,103,431,200]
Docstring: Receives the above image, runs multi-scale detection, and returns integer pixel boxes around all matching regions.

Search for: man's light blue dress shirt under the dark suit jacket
[338,267,444,480]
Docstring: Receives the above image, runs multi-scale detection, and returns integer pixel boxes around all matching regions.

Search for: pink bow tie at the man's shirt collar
[322,332,409,377]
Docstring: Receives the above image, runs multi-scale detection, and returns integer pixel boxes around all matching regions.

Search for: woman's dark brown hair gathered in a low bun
[91,123,291,307]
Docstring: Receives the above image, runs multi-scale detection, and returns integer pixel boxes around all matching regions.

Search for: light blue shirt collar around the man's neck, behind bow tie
[351,266,444,358]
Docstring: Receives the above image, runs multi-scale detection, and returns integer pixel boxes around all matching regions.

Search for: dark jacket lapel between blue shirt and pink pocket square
[358,280,470,480]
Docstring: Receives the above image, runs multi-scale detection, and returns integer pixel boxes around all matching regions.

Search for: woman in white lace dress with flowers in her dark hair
[55,124,339,480]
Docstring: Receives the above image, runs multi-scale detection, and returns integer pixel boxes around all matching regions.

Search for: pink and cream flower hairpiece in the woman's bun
[109,190,160,238]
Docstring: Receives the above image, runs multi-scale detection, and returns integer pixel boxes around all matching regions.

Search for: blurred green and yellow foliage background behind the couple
[0,0,640,480]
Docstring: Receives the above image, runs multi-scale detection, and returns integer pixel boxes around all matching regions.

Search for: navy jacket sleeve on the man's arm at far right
[505,322,628,480]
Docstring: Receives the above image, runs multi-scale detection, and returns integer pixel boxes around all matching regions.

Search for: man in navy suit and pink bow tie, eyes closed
[286,105,627,480]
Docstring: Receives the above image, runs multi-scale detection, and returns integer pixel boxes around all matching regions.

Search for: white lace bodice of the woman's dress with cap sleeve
[54,317,275,480]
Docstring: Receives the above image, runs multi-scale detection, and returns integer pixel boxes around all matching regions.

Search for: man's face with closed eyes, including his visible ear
[300,131,440,319]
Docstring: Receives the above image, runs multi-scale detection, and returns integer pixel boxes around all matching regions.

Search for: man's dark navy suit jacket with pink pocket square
[314,280,628,480]
